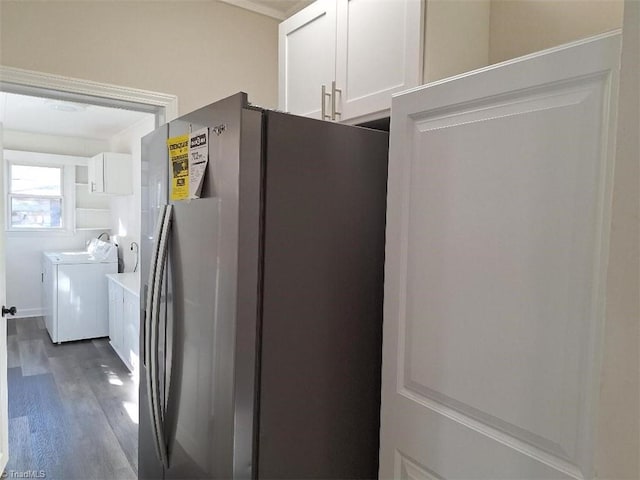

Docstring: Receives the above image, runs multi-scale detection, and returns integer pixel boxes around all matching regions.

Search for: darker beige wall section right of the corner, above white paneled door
[489,0,623,63]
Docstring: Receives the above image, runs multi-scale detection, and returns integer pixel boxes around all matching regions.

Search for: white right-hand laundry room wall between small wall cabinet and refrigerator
[109,115,155,272]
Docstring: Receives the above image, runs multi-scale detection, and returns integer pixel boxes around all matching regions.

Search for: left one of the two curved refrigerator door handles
[143,205,167,468]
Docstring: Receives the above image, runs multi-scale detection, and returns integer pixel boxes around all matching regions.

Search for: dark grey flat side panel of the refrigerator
[258,112,388,480]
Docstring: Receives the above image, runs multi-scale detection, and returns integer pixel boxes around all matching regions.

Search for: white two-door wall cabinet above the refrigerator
[278,0,424,123]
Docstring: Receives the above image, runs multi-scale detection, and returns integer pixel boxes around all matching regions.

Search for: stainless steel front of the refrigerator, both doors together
[139,93,262,480]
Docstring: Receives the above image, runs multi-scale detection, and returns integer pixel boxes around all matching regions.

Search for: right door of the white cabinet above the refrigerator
[335,0,424,121]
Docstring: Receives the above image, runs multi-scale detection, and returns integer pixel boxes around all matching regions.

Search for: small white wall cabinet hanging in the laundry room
[88,152,133,195]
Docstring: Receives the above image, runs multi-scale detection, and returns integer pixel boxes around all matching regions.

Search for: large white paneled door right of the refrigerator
[380,34,620,480]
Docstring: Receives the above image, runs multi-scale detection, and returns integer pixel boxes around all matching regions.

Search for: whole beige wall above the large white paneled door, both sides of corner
[423,0,623,83]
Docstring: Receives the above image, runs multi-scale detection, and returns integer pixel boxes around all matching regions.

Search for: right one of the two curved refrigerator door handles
[148,205,173,469]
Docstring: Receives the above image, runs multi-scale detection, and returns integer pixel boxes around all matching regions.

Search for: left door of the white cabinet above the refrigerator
[278,0,336,118]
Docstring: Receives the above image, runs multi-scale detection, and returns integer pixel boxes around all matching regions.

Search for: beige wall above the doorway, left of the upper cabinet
[0,0,278,114]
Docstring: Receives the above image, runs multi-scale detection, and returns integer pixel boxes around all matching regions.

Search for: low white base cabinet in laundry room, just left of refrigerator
[109,275,140,373]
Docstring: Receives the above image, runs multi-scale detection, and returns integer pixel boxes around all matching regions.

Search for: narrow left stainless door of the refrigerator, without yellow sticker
[138,125,169,480]
